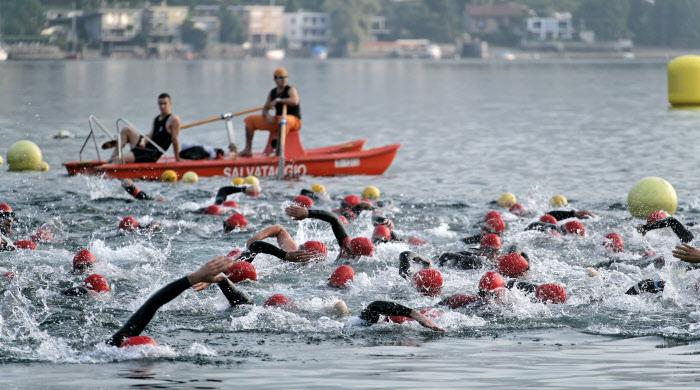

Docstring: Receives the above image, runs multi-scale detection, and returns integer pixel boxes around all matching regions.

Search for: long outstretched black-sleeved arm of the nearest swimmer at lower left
[107,256,231,346]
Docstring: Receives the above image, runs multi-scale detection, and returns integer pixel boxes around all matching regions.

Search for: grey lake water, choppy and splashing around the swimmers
[0,61,700,388]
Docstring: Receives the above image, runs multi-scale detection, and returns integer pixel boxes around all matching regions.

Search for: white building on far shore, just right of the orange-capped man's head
[284,10,331,54]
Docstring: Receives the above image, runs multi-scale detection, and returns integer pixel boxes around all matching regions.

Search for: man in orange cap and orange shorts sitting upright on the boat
[238,68,301,157]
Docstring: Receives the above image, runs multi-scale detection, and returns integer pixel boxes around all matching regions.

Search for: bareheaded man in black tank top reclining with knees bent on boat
[102,93,180,164]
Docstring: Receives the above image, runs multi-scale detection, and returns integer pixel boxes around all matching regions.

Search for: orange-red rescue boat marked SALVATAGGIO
[63,119,401,180]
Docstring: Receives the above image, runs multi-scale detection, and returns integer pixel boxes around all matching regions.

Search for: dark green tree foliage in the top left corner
[0,0,46,36]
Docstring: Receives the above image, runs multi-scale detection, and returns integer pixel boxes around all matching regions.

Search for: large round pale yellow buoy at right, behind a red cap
[627,176,678,218]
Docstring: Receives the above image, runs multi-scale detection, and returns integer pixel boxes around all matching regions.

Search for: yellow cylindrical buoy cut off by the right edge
[668,56,700,107]
